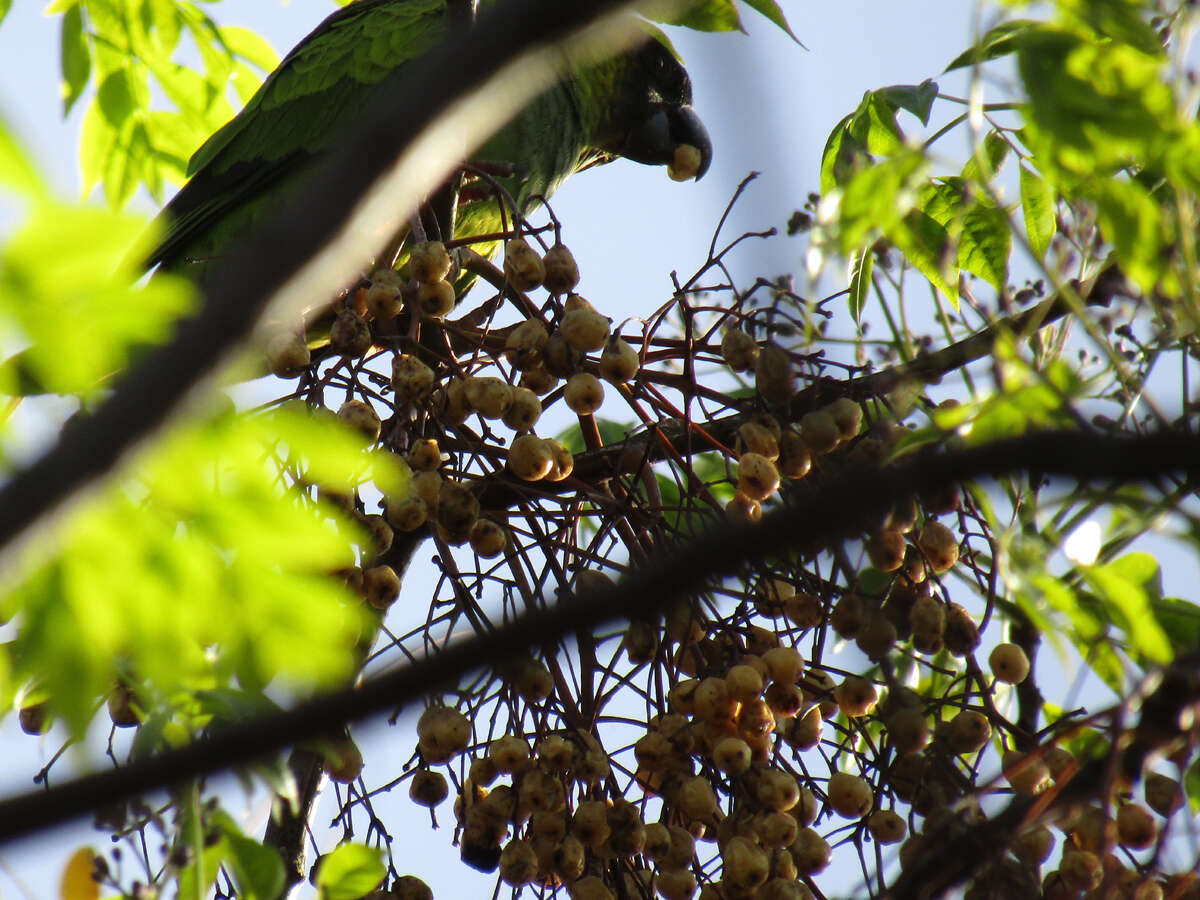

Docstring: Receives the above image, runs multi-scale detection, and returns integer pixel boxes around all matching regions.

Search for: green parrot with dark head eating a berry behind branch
[148,0,712,287]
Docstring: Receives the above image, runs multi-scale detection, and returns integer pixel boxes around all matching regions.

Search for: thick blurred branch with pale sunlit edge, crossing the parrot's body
[0,0,648,573]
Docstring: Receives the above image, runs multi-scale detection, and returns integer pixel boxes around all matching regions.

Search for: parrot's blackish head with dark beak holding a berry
[608,38,713,179]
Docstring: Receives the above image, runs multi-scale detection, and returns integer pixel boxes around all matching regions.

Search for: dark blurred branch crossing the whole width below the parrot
[0,432,1200,844]
